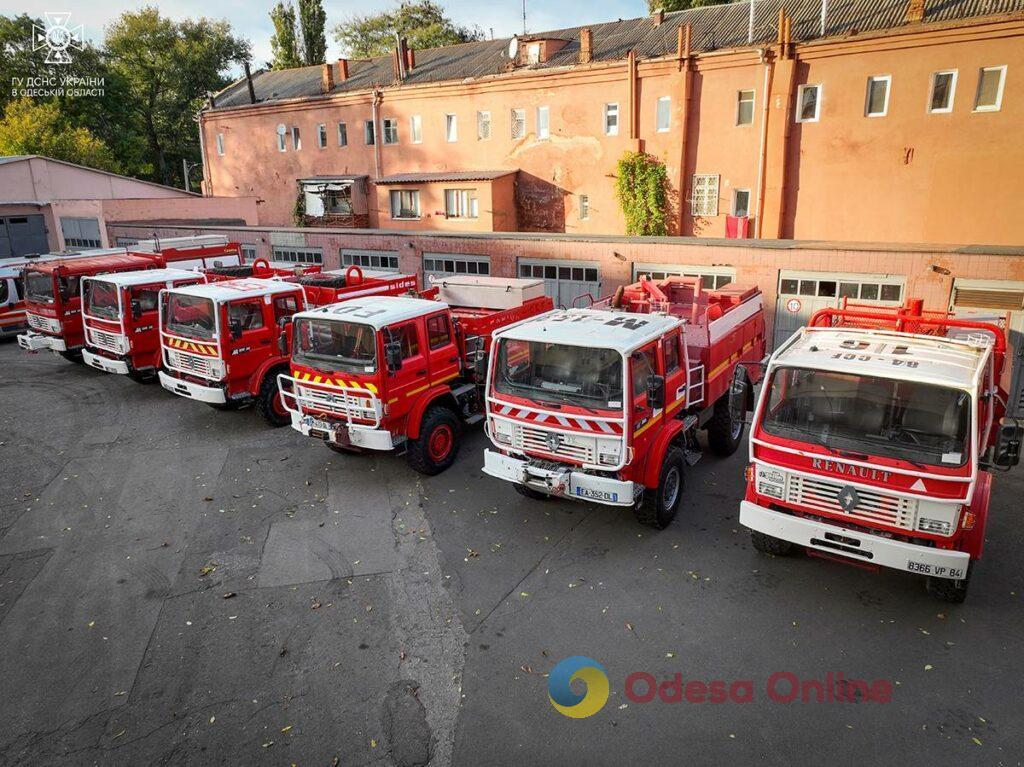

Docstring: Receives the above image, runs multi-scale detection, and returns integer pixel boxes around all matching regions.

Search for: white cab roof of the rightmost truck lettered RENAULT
[772,328,992,390]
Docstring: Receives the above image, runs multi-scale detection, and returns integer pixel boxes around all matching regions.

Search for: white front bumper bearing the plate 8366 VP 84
[739,501,971,580]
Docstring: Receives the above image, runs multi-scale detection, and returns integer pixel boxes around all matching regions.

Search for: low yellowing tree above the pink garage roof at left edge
[0,98,121,172]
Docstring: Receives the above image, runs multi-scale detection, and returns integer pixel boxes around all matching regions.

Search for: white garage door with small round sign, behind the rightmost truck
[774,270,906,348]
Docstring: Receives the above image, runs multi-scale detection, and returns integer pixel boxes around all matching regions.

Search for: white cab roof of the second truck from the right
[495,309,683,354]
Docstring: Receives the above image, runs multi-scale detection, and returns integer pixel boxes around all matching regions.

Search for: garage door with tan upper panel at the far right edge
[952,280,1024,417]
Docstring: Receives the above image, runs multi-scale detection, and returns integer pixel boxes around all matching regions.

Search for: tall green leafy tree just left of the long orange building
[105,7,250,185]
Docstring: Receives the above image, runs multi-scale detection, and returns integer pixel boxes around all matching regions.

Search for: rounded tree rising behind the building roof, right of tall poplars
[334,0,483,58]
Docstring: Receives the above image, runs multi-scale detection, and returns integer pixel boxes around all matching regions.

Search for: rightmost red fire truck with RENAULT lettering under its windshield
[739,300,1021,602]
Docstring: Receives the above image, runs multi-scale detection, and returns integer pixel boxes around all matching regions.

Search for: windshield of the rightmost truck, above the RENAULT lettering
[762,368,971,466]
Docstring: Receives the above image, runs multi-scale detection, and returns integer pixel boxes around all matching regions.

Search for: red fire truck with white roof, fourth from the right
[158,266,417,426]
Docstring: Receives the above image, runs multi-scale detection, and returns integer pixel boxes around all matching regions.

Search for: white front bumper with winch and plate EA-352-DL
[483,451,637,506]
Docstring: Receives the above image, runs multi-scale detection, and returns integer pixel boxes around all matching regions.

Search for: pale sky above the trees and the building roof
[0,0,647,69]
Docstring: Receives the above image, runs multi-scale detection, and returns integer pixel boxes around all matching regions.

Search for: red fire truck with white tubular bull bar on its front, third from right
[279,276,553,475]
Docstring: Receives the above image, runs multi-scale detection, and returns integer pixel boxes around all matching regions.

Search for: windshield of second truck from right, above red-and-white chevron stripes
[495,339,623,411]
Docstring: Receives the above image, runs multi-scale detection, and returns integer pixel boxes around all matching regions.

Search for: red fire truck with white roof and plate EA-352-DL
[483,276,765,529]
